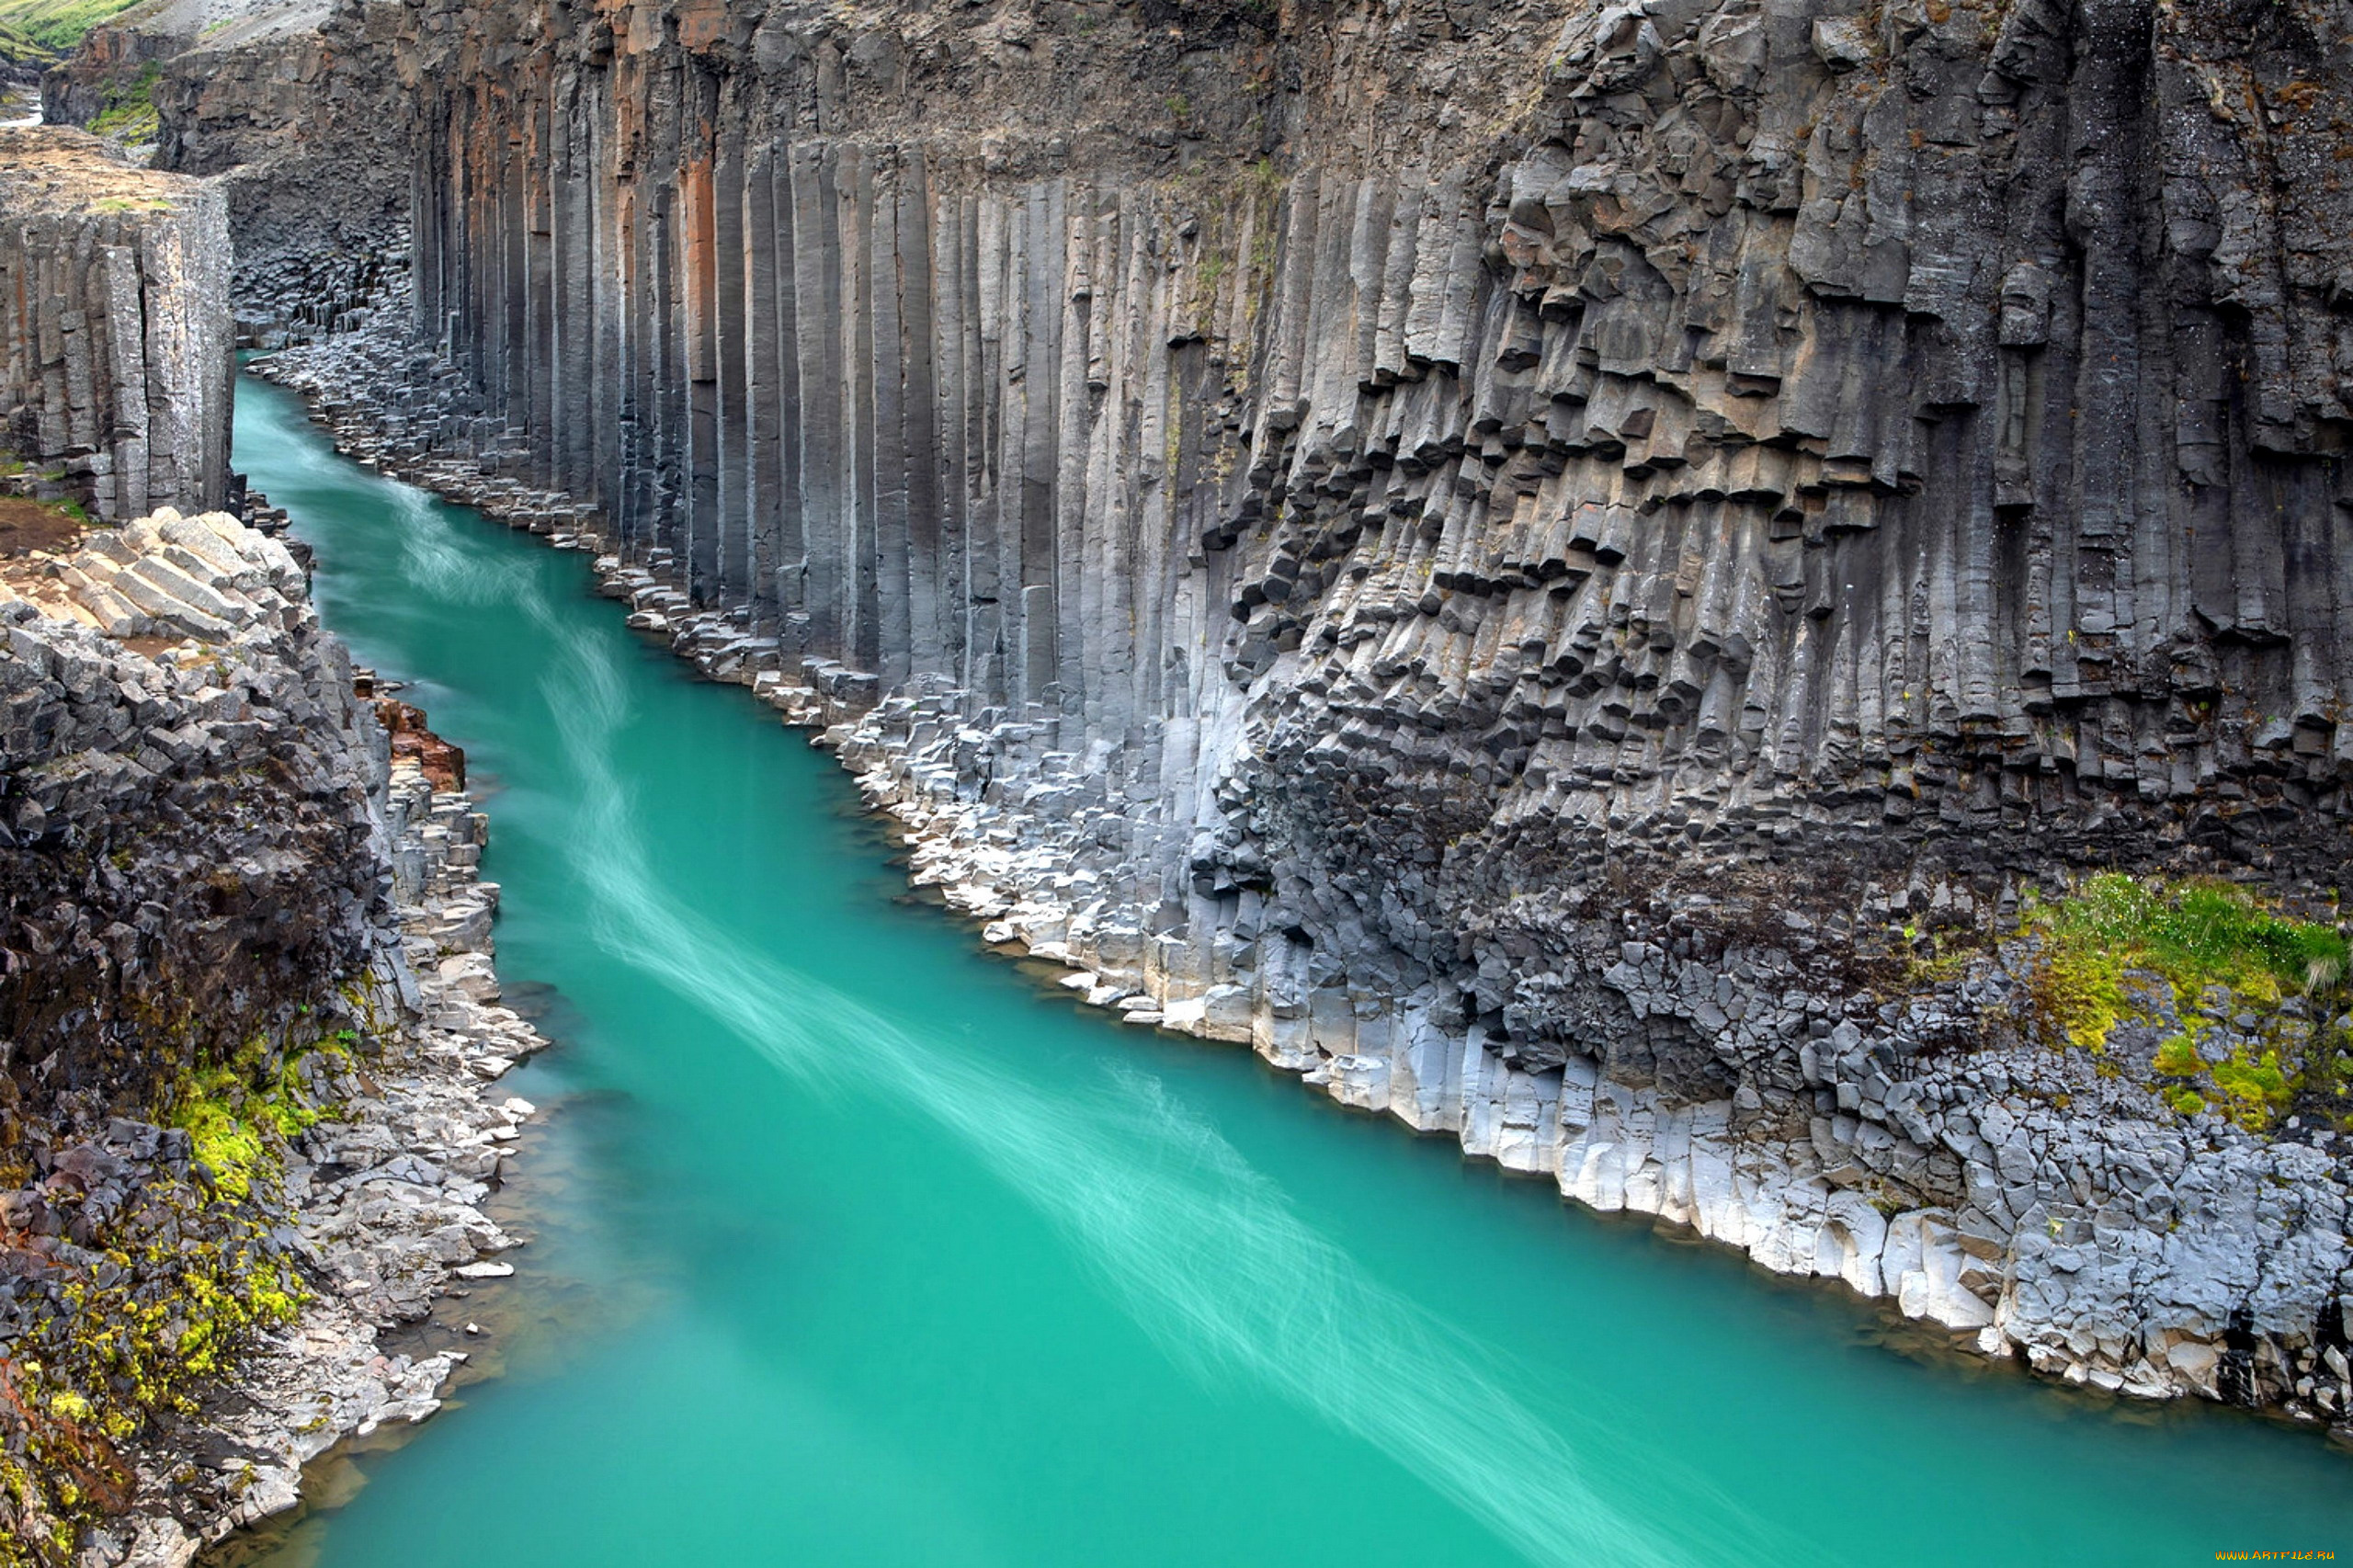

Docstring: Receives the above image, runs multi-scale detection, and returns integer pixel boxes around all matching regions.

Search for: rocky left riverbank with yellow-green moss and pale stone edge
[0,511,541,1568]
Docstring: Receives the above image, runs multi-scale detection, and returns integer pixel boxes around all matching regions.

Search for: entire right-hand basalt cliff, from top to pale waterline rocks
[172,0,2353,1420]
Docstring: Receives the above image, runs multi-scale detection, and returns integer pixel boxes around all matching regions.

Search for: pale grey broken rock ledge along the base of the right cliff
[253,290,2353,1425]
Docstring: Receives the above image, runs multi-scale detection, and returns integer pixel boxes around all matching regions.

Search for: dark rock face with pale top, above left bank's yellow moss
[0,501,383,1119]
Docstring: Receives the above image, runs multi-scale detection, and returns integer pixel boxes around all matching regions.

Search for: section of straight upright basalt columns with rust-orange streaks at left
[416,45,1280,739]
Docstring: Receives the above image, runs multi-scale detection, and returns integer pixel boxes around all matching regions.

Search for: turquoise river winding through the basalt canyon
[238,379,2353,1568]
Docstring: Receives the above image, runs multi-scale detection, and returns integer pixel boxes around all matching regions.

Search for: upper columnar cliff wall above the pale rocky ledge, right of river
[336,5,2353,857]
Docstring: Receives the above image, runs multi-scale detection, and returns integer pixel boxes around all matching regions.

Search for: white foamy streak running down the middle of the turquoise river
[522,612,1795,1568]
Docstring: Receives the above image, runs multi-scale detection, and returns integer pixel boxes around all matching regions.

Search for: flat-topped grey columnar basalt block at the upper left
[0,130,235,520]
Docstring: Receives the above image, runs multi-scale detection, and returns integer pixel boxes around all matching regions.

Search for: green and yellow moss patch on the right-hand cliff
[2024,873,2353,1132]
